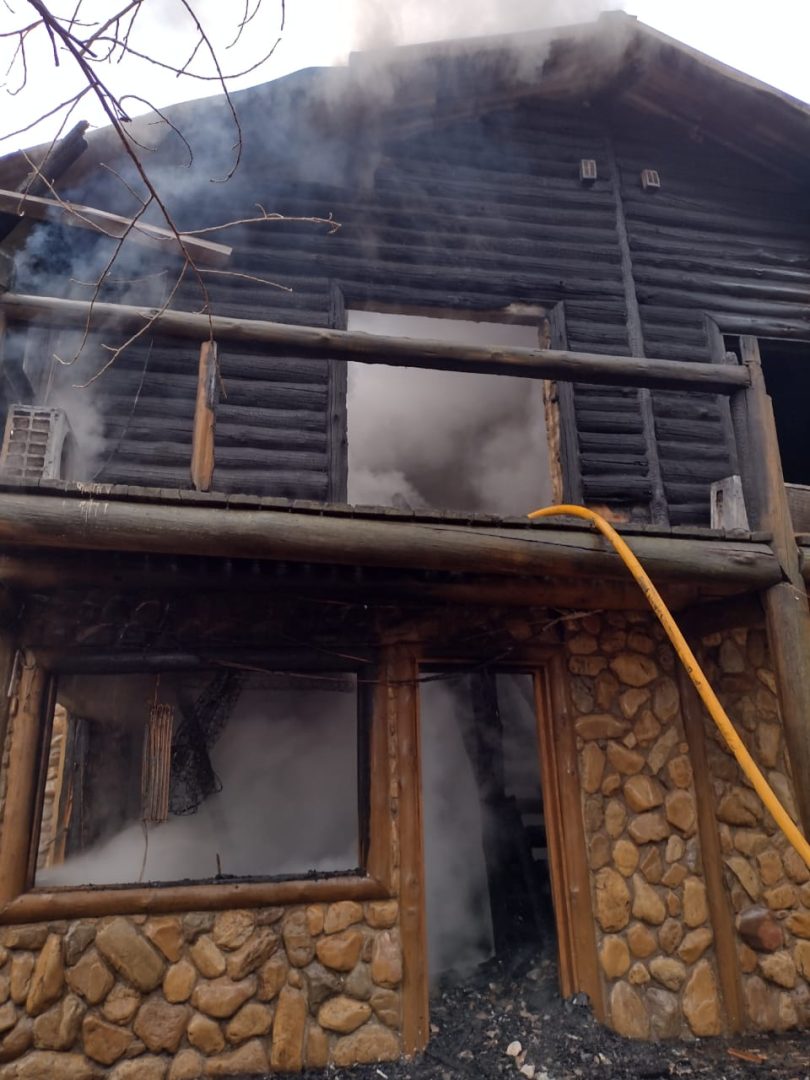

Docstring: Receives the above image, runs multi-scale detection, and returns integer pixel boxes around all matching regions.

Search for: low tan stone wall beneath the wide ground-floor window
[0,901,402,1080]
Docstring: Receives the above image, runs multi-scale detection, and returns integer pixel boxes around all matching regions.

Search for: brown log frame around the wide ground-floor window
[0,648,396,924]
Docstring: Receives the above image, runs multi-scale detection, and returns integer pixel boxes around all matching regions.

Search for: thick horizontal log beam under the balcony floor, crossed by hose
[0,492,780,589]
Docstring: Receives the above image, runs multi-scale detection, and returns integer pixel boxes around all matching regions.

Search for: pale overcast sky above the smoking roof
[0,0,810,153]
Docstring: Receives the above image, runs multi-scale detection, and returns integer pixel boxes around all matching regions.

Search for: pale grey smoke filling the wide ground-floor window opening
[37,680,357,886]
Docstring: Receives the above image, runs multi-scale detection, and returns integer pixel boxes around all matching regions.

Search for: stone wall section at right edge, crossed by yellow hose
[702,630,810,1031]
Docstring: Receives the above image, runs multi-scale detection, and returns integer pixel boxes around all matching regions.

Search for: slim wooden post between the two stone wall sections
[677,664,745,1031]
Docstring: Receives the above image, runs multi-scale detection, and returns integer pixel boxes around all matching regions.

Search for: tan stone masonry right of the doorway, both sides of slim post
[567,613,810,1038]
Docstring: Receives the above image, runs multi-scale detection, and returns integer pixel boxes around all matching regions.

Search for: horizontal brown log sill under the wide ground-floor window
[0,874,389,924]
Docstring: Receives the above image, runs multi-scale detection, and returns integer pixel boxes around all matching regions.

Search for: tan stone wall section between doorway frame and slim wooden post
[567,612,724,1039]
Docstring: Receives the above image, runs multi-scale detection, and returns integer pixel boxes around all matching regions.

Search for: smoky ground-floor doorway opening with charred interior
[420,670,556,983]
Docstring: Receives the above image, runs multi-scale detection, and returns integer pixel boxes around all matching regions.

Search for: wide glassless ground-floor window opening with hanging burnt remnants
[33,669,368,887]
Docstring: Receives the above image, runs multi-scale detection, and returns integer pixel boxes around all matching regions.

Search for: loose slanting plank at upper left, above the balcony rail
[0,188,233,267]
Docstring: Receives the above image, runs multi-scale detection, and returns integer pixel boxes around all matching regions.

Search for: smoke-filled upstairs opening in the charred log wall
[347,309,552,516]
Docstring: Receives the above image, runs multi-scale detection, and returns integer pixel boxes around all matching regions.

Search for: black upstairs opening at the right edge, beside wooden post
[726,337,810,485]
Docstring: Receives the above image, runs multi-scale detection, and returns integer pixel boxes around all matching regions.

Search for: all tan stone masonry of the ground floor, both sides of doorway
[0,612,810,1080]
